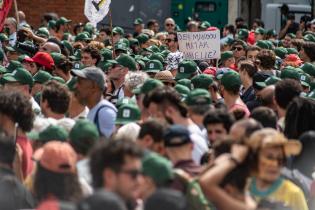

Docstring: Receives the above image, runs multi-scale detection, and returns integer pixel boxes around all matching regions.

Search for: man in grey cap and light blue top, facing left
[72,67,117,138]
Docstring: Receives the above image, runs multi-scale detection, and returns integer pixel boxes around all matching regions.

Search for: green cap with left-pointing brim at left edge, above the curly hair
[2,68,34,87]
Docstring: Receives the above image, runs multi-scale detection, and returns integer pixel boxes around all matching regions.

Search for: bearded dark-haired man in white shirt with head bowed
[144,86,208,164]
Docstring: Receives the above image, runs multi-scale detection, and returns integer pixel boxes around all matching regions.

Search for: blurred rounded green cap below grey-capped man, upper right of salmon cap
[69,119,100,146]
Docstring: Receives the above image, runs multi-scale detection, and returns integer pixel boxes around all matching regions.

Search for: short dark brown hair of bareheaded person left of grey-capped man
[42,80,70,114]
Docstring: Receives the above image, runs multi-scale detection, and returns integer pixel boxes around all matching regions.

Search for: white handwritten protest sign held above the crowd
[177,30,220,60]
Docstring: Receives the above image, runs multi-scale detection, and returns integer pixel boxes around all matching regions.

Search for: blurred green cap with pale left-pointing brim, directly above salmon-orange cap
[27,125,68,143]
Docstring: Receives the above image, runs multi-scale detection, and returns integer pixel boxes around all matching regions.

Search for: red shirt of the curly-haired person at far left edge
[16,136,33,178]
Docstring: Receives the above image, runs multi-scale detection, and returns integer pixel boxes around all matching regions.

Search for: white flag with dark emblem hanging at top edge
[84,0,111,27]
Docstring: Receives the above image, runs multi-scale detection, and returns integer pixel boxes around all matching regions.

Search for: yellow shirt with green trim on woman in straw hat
[250,178,308,210]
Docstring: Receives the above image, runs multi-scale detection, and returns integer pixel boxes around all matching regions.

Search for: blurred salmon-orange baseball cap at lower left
[33,141,77,173]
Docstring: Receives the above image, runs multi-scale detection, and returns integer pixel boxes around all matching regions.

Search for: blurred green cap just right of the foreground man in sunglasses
[142,152,174,186]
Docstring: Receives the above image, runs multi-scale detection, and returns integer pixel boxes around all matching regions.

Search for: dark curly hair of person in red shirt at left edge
[0,90,35,132]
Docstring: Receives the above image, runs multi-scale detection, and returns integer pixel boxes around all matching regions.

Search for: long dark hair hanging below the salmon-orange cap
[34,164,83,202]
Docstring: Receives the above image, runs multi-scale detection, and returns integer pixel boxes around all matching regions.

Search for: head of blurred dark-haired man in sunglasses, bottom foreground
[90,140,142,209]
